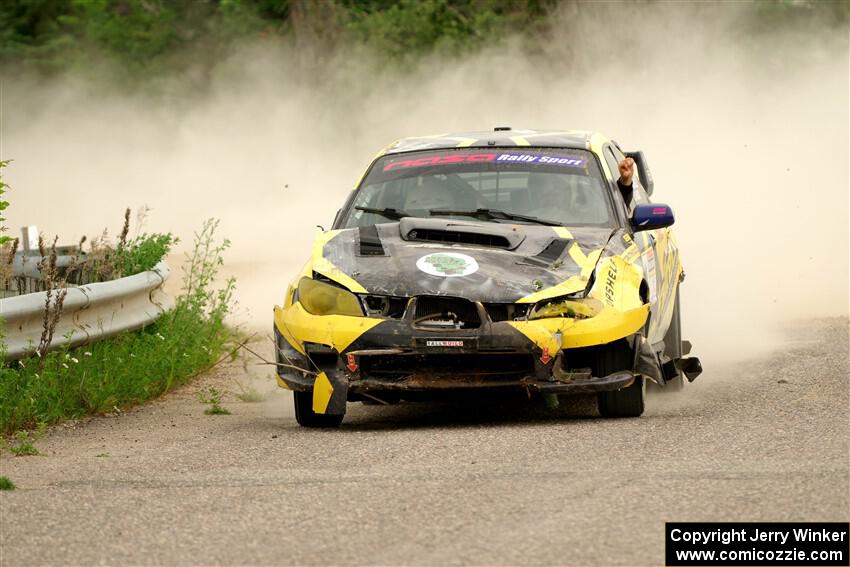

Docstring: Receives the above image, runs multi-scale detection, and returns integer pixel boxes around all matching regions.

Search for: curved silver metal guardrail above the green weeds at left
[0,262,174,360]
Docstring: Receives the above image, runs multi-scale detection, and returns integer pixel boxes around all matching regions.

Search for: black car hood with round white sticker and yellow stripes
[314,218,613,303]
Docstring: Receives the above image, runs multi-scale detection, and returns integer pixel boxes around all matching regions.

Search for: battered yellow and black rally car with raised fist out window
[274,127,701,427]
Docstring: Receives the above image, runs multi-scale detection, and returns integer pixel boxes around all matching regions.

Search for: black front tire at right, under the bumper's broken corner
[596,339,646,417]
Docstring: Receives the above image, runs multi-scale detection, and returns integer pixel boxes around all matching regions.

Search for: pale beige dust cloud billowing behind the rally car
[0,3,850,361]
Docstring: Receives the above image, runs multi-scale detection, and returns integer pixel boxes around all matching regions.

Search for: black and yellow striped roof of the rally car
[386,126,594,154]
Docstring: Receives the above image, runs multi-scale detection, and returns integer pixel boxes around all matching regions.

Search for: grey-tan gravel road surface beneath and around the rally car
[0,318,850,565]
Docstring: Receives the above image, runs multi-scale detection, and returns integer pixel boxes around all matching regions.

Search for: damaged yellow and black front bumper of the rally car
[274,296,649,415]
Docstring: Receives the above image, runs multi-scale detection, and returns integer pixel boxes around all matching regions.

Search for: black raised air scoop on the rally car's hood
[398,217,525,250]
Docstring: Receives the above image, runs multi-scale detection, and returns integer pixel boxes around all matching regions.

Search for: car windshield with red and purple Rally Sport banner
[339,148,614,228]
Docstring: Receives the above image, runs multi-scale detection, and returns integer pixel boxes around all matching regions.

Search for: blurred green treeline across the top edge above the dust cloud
[0,0,848,81]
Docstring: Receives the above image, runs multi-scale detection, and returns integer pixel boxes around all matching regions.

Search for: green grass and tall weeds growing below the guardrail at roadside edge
[0,221,235,433]
